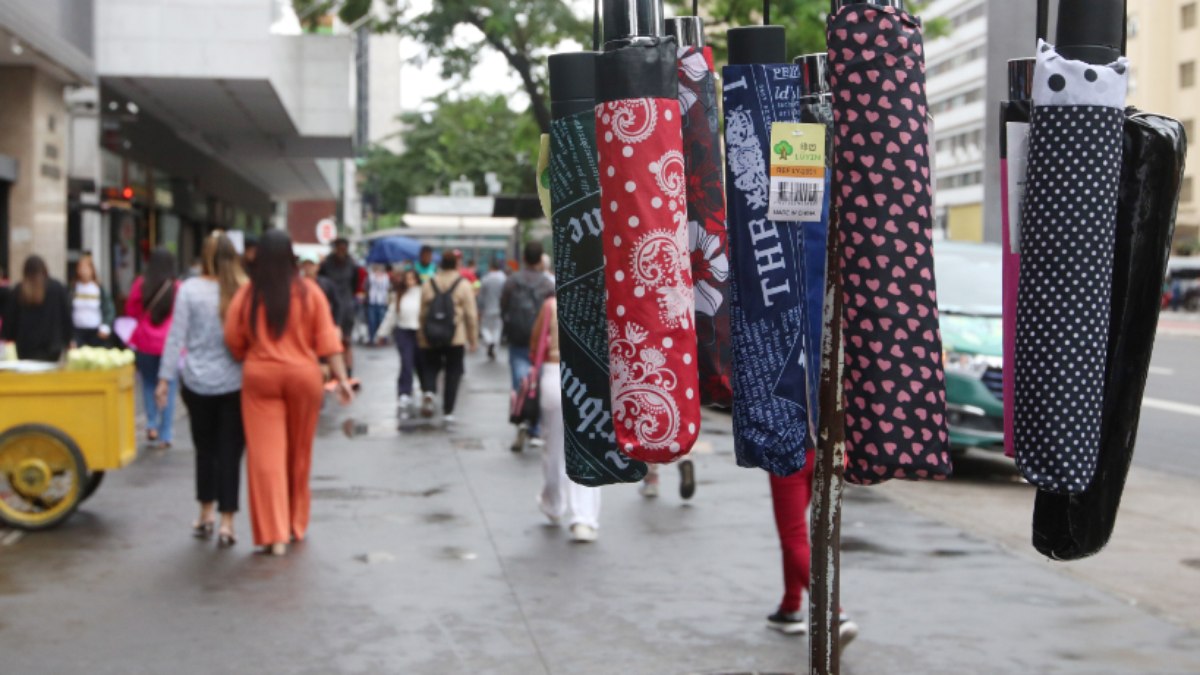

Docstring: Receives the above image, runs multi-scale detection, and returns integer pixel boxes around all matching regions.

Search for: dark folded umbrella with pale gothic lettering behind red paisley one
[548,52,647,486]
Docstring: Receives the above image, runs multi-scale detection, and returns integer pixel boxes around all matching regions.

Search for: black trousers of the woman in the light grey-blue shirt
[180,386,246,513]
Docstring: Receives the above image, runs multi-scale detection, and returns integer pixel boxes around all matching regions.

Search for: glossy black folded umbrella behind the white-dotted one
[1033,110,1187,560]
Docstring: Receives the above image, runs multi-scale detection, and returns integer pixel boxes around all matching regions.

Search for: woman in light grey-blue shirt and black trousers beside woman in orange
[155,233,246,548]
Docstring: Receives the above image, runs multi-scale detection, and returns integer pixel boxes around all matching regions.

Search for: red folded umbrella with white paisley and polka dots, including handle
[595,0,700,462]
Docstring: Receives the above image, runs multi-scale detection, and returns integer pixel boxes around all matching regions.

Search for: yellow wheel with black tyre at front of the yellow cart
[0,424,87,530]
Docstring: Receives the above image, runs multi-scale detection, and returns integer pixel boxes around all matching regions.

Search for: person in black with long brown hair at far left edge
[0,256,74,363]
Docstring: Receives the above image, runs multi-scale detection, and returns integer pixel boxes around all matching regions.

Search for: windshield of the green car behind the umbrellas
[934,241,1003,315]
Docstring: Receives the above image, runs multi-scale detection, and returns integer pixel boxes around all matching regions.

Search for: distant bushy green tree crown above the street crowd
[359,95,539,214]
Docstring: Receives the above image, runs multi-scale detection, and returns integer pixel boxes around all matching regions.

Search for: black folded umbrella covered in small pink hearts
[828,5,952,485]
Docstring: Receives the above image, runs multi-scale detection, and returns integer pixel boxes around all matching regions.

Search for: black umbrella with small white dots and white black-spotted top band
[1014,42,1128,494]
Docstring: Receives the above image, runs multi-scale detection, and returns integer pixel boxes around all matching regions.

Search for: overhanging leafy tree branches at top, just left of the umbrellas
[376,0,590,133]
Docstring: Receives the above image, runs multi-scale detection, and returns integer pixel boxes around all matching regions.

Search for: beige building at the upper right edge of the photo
[1128,0,1200,245]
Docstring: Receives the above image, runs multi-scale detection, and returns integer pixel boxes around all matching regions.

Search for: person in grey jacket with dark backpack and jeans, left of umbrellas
[500,241,554,453]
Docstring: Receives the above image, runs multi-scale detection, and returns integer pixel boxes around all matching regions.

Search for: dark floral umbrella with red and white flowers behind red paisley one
[666,17,733,407]
